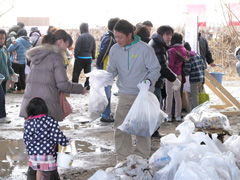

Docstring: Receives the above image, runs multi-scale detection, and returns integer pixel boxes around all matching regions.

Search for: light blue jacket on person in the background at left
[8,36,32,64]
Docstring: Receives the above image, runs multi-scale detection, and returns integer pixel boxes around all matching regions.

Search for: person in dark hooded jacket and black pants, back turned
[72,23,96,90]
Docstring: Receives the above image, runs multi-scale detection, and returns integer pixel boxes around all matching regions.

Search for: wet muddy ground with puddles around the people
[0,81,240,180]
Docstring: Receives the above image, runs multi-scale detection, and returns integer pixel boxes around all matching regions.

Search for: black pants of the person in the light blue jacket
[12,63,25,90]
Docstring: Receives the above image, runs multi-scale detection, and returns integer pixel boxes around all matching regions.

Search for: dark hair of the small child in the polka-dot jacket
[26,97,48,117]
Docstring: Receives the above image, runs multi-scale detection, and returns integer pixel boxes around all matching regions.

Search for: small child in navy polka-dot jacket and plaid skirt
[23,97,69,180]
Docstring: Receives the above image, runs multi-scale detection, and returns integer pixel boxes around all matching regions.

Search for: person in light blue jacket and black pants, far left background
[8,29,32,93]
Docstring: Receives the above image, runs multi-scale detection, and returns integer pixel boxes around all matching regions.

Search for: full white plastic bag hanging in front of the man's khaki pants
[118,83,167,137]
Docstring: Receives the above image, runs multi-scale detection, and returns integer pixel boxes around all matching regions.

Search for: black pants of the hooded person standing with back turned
[72,58,92,87]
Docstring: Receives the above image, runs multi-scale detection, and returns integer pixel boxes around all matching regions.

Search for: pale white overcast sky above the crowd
[0,0,239,28]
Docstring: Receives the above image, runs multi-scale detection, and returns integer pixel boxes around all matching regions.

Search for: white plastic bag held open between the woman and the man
[86,70,113,114]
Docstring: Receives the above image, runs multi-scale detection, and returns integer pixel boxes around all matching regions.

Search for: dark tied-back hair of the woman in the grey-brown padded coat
[42,29,68,44]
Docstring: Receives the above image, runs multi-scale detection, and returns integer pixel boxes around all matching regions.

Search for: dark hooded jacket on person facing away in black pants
[74,23,96,59]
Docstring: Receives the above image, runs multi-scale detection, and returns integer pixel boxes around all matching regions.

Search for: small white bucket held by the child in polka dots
[57,143,74,168]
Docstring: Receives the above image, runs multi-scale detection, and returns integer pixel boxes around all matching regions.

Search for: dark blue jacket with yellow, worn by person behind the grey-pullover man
[96,31,116,70]
